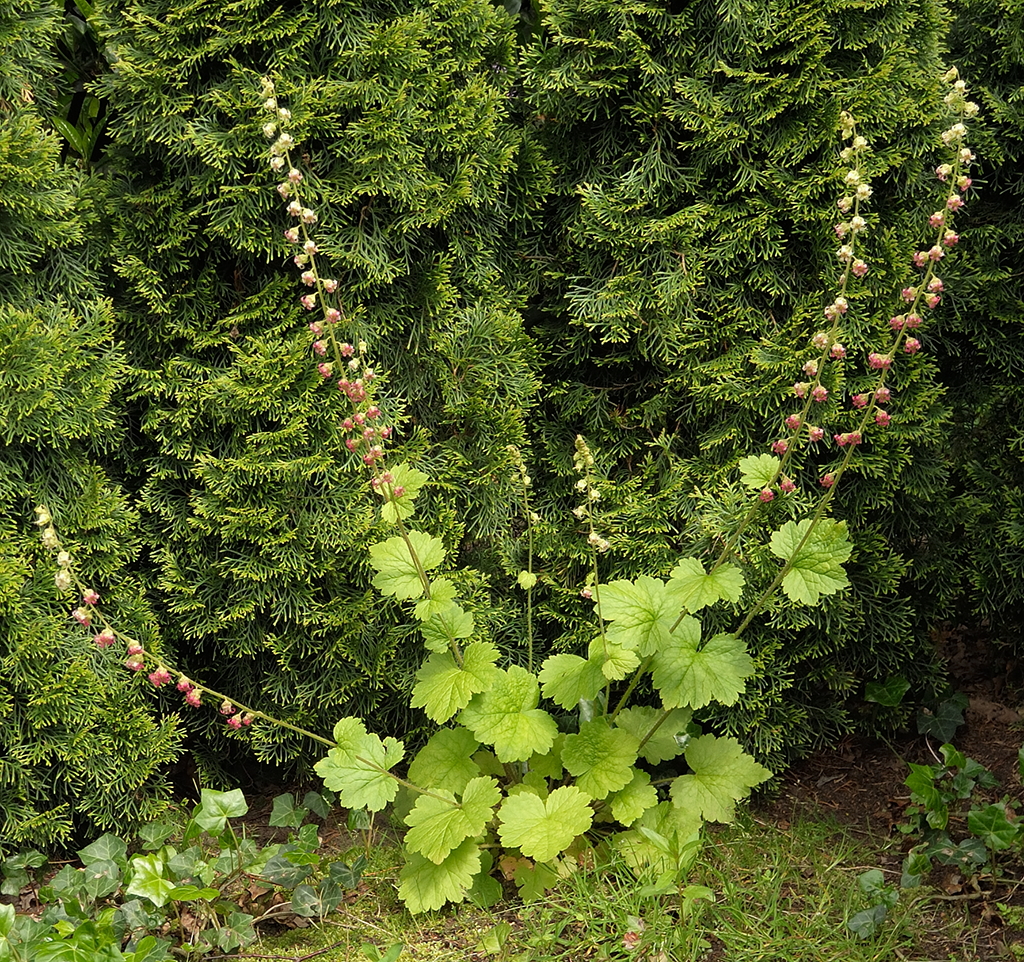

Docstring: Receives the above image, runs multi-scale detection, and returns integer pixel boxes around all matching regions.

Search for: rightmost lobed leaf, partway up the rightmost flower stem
[770,517,853,604]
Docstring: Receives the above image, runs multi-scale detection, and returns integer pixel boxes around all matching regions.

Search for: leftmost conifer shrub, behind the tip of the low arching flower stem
[0,22,178,853]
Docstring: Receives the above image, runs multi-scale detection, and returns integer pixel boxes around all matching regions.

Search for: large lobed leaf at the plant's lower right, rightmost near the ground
[672,735,771,822]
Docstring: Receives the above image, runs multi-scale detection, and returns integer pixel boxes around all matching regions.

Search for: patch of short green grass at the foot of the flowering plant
[248,813,978,962]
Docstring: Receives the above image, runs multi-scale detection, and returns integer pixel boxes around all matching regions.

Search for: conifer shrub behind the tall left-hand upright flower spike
[95,0,536,774]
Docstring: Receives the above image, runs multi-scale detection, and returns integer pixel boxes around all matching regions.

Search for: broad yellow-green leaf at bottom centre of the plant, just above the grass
[498,785,594,862]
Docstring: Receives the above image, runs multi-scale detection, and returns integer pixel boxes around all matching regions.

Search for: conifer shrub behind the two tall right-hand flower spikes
[516,0,948,762]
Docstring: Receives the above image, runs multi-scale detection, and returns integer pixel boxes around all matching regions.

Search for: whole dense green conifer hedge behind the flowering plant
[0,0,1024,838]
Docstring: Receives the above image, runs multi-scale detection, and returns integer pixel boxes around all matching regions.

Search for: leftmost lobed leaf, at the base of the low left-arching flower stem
[313,718,406,811]
